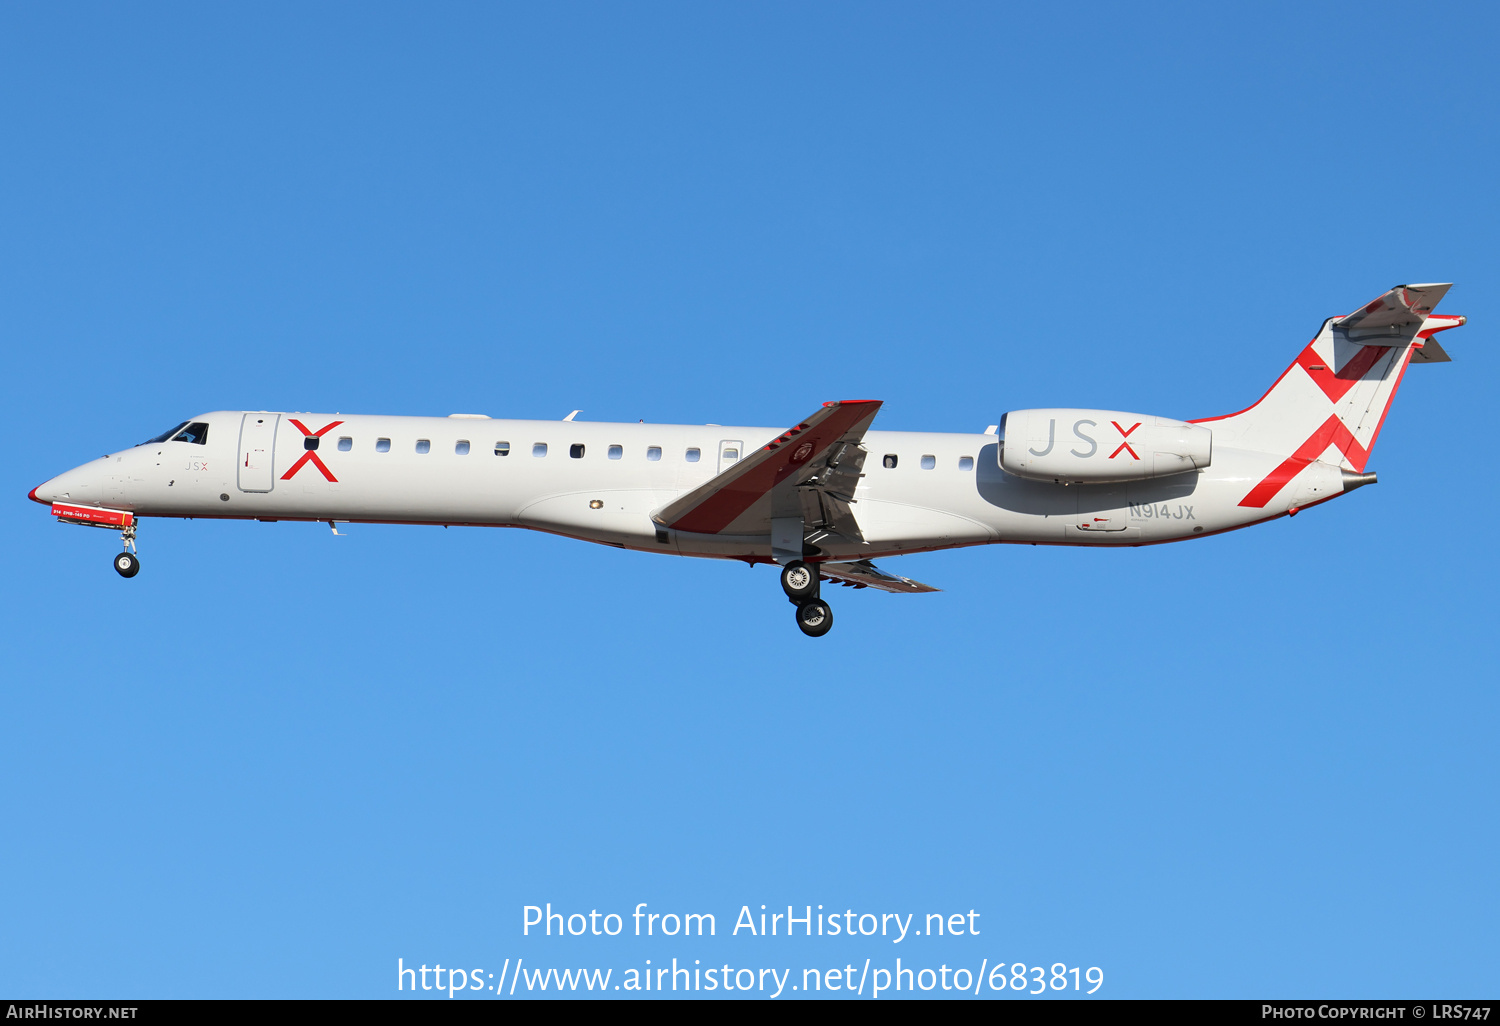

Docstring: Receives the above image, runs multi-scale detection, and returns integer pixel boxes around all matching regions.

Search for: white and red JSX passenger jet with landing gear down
[29,284,1466,638]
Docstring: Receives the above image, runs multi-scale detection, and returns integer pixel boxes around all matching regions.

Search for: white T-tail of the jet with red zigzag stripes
[1194,284,1466,509]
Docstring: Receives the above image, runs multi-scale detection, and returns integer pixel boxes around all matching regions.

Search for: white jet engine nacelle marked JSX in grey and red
[1001,410,1214,485]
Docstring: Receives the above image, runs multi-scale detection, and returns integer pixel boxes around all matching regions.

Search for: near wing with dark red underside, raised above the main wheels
[653,399,881,542]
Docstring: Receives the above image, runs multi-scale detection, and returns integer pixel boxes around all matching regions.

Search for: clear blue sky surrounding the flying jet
[0,3,1500,998]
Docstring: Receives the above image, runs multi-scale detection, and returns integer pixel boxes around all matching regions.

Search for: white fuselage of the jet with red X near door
[35,411,1343,561]
